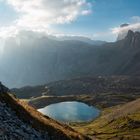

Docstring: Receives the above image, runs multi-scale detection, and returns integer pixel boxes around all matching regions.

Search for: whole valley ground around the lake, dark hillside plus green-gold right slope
[13,77,140,140]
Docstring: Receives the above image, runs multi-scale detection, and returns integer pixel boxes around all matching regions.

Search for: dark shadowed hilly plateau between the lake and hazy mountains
[12,76,140,108]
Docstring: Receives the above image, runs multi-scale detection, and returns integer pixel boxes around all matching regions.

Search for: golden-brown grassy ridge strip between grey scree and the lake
[0,93,88,140]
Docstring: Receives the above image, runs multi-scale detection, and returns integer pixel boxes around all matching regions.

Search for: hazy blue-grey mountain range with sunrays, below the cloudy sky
[0,31,140,87]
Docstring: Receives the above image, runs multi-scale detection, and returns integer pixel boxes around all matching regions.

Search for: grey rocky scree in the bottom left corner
[0,102,49,140]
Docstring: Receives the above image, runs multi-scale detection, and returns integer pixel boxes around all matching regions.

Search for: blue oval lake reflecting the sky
[38,101,100,122]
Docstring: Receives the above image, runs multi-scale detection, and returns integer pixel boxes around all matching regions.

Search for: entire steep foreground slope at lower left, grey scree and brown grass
[0,84,89,140]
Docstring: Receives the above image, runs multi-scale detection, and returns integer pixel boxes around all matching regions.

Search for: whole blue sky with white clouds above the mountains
[0,0,140,41]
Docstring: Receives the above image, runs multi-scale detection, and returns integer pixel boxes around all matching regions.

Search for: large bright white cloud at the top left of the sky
[7,0,92,29]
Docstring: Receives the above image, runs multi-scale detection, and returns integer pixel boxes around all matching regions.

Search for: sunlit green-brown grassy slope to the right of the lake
[72,99,140,140]
